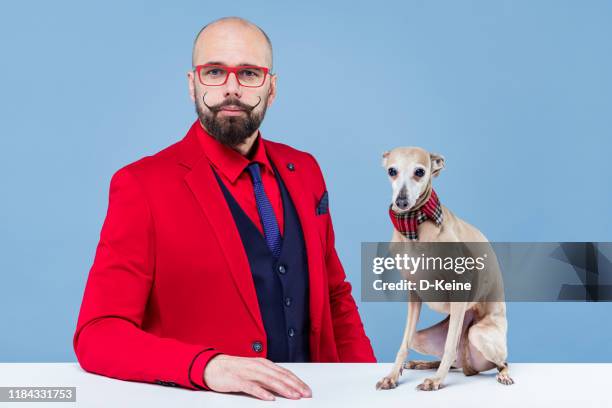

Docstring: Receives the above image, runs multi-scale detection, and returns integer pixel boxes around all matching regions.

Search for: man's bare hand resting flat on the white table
[204,354,312,401]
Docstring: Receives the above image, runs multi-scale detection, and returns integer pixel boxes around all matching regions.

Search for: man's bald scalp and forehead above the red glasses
[192,17,272,71]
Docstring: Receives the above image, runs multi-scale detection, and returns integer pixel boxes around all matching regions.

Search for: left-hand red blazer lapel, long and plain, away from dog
[181,127,265,333]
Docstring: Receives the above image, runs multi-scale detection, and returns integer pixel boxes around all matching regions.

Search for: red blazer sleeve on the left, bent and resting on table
[73,167,221,389]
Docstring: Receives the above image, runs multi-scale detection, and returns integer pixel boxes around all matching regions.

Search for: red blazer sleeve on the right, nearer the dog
[309,154,376,363]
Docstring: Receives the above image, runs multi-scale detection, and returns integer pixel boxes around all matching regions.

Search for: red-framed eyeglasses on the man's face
[195,64,269,88]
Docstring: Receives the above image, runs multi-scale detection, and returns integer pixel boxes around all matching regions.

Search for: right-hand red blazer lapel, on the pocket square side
[264,139,325,340]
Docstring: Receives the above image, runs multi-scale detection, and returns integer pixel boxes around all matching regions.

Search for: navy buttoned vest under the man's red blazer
[211,165,310,362]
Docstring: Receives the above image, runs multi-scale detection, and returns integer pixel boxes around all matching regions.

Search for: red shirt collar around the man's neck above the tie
[196,120,273,184]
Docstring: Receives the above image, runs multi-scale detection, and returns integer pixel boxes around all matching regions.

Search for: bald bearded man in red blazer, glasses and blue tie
[74,17,376,400]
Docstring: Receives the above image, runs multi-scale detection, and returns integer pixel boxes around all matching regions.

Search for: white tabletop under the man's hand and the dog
[0,363,612,408]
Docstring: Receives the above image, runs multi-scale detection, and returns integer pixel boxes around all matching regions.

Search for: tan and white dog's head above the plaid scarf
[382,147,444,212]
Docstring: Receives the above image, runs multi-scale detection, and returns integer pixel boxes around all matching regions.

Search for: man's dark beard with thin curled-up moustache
[195,93,267,148]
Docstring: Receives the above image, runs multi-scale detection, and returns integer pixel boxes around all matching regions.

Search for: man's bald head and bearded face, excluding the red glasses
[188,22,276,147]
